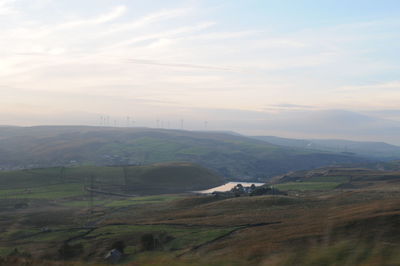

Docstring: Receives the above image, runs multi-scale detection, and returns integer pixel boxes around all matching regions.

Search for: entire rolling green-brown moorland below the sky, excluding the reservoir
[0,127,400,265]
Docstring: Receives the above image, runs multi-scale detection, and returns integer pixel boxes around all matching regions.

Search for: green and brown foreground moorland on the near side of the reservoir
[0,166,400,266]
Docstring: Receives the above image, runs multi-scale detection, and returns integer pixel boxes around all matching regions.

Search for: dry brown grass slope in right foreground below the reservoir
[0,176,400,265]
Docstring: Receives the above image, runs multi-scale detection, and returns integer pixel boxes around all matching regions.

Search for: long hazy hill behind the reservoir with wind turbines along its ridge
[0,126,364,179]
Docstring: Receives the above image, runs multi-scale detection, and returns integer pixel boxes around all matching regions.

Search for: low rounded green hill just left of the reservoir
[0,163,224,195]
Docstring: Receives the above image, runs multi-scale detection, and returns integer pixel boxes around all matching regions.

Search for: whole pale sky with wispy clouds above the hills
[0,0,400,144]
